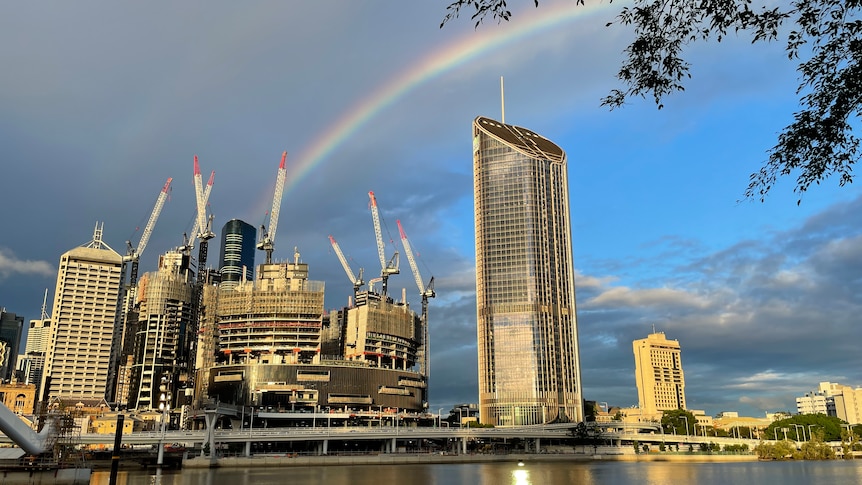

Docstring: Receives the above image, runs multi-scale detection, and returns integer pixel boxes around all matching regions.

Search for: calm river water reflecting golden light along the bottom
[90,460,862,485]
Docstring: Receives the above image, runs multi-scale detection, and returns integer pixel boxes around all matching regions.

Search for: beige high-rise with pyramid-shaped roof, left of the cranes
[40,224,123,405]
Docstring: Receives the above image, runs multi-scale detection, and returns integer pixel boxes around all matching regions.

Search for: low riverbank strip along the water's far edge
[183,453,757,468]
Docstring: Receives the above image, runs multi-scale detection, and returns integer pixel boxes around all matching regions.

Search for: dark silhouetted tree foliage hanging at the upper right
[441,0,862,204]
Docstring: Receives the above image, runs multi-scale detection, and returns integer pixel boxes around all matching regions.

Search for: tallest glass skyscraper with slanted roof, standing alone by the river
[473,117,583,426]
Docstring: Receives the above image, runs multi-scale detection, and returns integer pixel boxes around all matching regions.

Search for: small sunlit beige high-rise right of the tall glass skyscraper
[632,332,686,414]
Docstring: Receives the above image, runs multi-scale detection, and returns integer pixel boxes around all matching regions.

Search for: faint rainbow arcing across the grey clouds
[285,1,609,195]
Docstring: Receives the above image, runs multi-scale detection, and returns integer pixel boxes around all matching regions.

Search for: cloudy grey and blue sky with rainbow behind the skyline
[0,0,862,416]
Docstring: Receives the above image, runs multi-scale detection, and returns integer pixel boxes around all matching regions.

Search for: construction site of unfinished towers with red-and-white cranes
[49,152,435,428]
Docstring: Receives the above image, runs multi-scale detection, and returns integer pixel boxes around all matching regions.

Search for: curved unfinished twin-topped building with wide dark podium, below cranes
[197,253,426,412]
